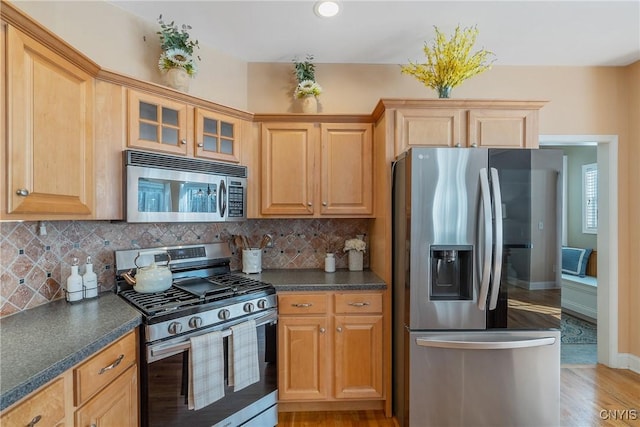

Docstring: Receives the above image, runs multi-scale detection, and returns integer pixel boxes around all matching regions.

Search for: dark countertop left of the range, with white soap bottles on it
[0,293,141,410]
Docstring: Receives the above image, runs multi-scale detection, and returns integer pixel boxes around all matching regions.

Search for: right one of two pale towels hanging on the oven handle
[228,320,260,391]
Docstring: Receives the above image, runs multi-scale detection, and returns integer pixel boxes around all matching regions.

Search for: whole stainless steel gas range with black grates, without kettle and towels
[115,242,278,427]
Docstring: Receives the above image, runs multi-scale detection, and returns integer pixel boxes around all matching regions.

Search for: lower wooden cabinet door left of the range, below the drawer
[75,366,138,427]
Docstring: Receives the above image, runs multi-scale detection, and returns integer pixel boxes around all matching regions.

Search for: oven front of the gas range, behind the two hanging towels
[140,310,278,427]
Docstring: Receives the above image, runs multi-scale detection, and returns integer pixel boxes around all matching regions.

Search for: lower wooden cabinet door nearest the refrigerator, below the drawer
[334,315,382,399]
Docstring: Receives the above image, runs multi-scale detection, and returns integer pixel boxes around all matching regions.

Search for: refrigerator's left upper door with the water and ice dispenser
[404,148,491,330]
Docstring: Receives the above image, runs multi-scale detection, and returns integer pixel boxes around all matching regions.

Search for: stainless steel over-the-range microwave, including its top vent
[124,150,247,222]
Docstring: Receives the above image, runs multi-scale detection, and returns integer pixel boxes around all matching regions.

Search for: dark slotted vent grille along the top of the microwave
[125,150,247,178]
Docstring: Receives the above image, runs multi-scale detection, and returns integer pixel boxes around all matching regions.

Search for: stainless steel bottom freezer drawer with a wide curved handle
[410,330,560,427]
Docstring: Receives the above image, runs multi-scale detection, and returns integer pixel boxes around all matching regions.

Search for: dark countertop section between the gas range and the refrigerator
[238,269,387,291]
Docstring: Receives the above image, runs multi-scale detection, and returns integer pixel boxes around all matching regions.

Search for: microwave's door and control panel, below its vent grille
[126,165,246,222]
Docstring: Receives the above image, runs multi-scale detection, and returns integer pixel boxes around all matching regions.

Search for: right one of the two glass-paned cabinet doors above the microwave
[195,108,242,163]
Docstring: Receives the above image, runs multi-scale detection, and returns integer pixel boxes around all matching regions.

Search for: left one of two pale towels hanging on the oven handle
[189,332,224,410]
